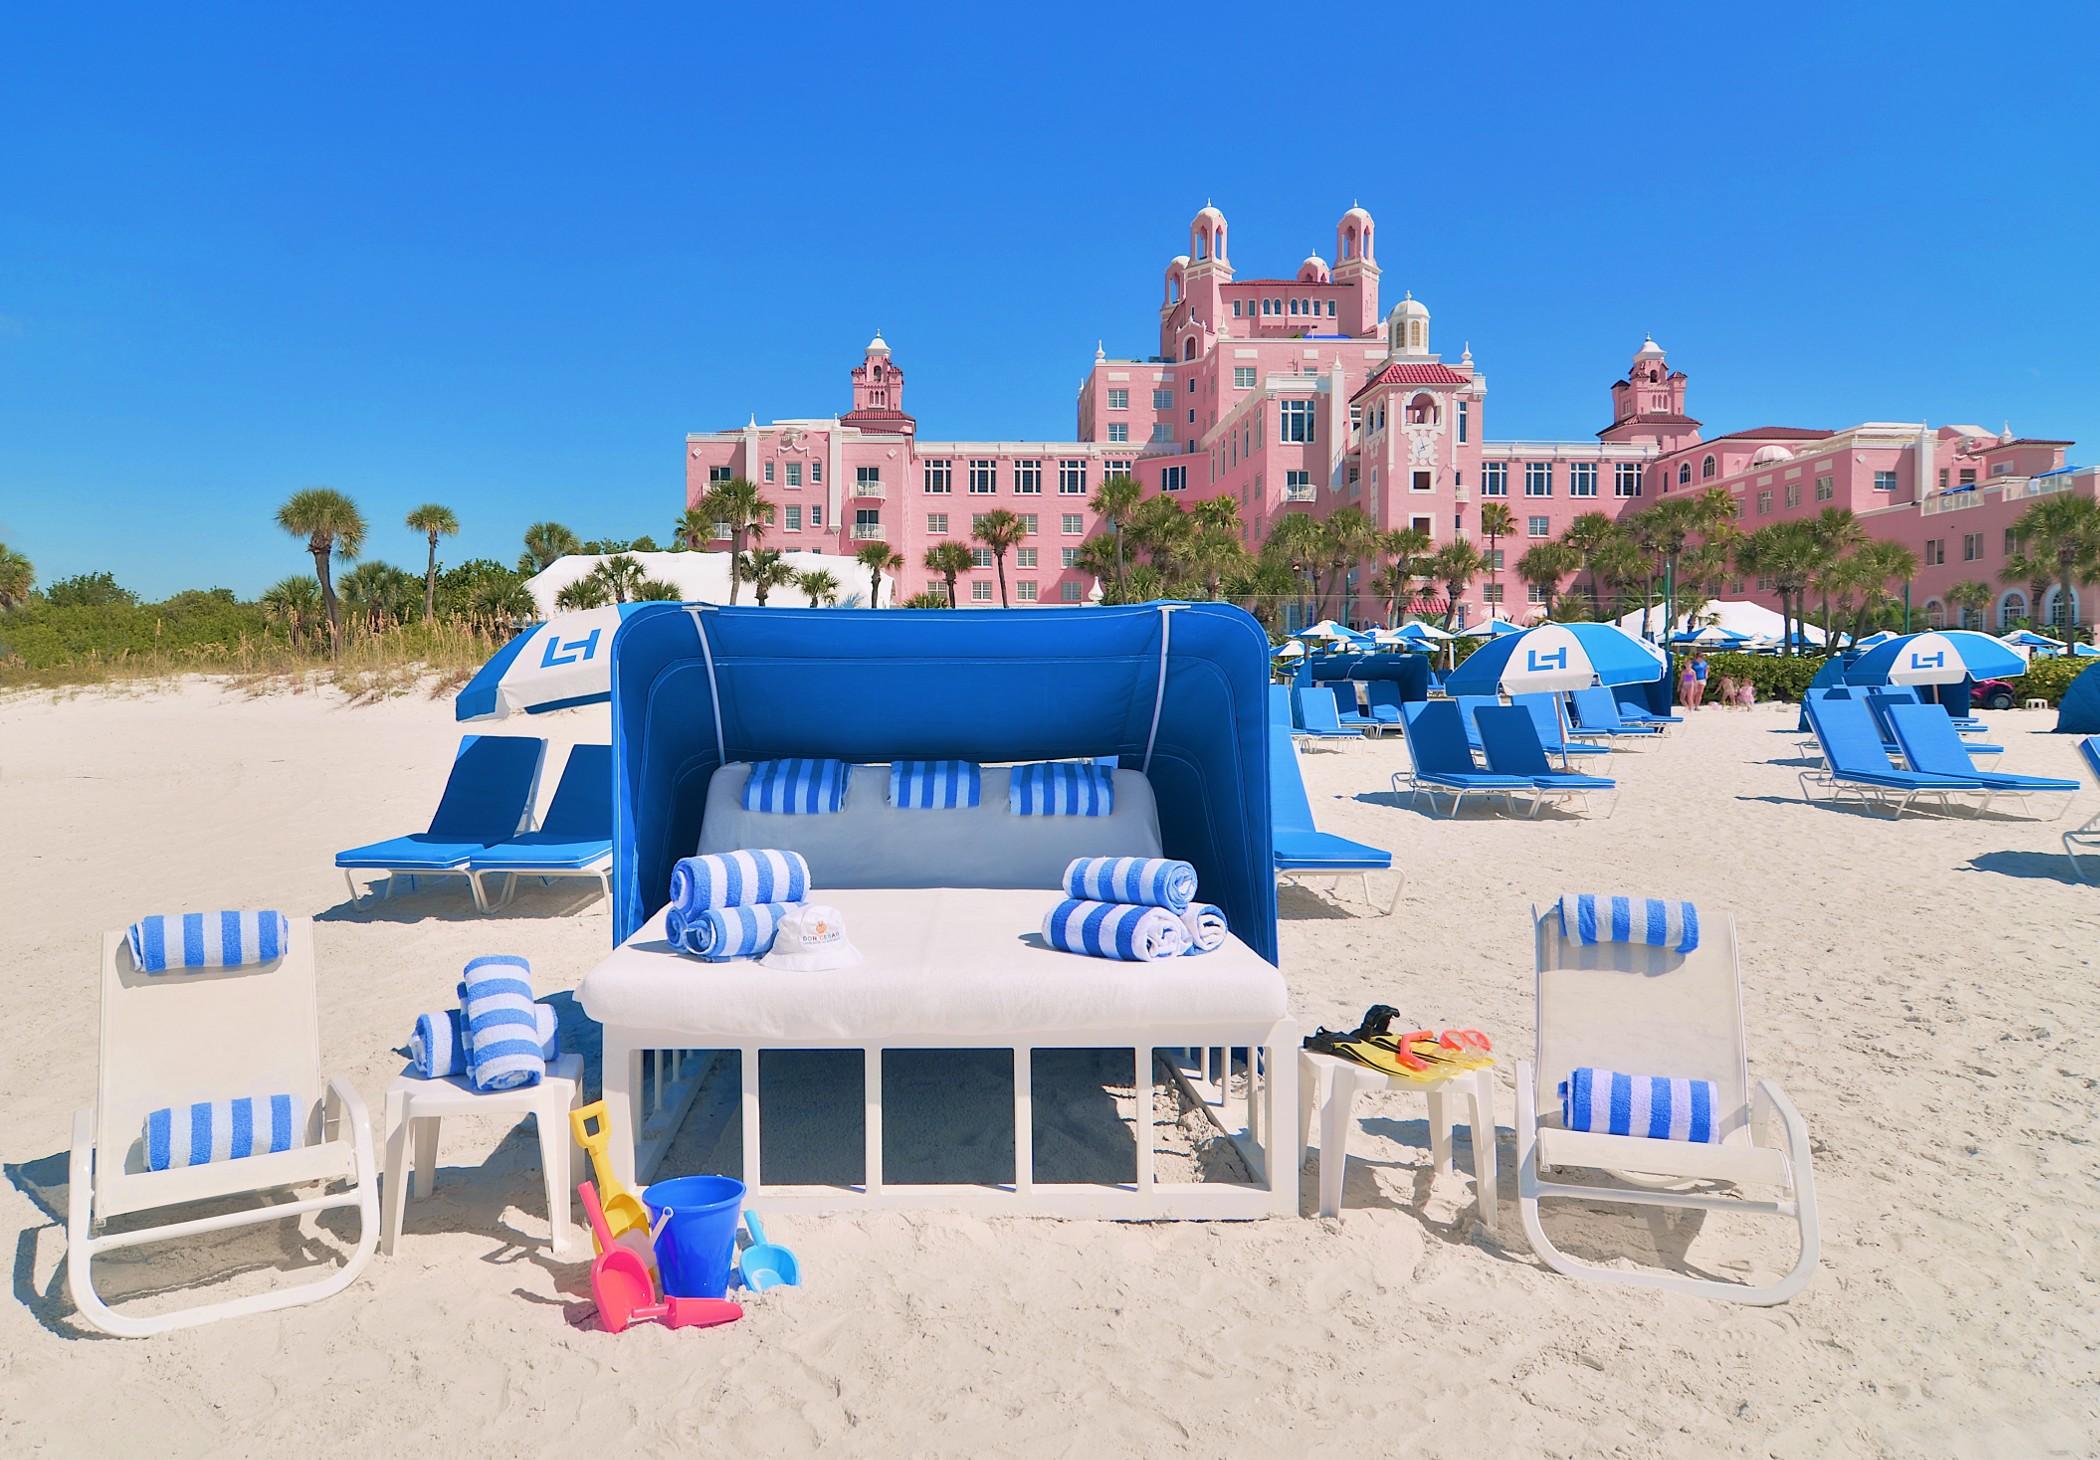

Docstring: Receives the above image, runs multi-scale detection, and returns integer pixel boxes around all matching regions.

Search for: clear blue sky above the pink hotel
[0,4,2100,597]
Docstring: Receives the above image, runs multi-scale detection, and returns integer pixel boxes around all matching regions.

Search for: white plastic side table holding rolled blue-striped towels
[380,1055,590,1263]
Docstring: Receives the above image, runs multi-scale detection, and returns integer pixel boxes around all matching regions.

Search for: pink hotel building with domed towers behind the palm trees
[685,208,2100,626]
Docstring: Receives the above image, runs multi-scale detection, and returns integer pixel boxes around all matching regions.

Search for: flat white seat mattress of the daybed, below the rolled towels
[578,887,1285,1048]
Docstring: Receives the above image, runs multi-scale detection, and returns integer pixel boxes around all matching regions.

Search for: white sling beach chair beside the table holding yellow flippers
[1516,903,1819,1305]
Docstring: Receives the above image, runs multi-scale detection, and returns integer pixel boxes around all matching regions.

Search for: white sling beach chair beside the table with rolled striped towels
[65,918,380,1338]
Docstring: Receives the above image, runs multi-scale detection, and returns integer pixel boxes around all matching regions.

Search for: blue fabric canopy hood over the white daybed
[613,603,1277,962]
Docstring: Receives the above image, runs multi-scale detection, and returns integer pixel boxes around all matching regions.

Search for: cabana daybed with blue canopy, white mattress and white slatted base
[580,605,1298,1216]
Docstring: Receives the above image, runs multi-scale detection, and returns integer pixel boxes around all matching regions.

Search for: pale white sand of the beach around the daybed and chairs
[0,681,2100,1456]
